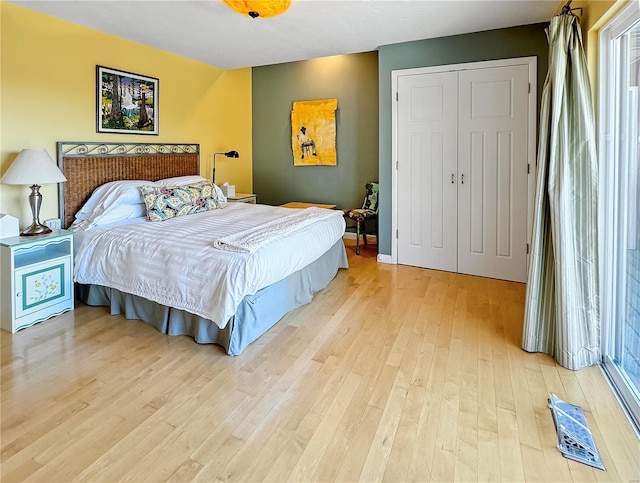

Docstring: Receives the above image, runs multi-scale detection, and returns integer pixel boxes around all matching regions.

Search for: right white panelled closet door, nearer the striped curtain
[458,65,529,282]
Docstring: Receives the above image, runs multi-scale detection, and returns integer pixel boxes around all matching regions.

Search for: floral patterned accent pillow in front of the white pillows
[140,181,220,221]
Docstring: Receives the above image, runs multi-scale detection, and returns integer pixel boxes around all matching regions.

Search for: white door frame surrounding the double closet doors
[378,56,538,271]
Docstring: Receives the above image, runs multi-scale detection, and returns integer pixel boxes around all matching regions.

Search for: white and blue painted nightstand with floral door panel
[0,230,73,332]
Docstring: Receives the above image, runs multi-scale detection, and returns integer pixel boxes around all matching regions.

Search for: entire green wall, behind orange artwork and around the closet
[252,23,548,255]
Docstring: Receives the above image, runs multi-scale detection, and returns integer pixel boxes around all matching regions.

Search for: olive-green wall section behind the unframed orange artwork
[252,52,378,208]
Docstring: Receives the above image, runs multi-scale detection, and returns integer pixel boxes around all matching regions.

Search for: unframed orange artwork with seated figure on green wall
[291,99,338,166]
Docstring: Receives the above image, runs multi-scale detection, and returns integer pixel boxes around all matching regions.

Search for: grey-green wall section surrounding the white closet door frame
[378,23,548,255]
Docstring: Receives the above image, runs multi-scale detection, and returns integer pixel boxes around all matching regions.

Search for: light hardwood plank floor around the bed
[0,242,640,482]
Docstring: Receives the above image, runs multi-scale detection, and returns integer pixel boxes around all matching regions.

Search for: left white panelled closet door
[397,72,458,272]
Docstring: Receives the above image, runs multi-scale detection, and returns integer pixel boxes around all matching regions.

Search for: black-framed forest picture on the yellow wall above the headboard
[96,65,159,135]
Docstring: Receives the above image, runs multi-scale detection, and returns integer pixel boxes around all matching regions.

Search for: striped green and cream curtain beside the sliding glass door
[522,13,601,370]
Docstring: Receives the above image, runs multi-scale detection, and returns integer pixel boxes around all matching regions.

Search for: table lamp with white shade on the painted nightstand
[0,149,67,236]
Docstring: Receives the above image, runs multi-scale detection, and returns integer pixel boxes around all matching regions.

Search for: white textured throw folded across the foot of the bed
[213,207,342,253]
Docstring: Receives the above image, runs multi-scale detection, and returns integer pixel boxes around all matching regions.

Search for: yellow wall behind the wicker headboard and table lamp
[0,2,253,227]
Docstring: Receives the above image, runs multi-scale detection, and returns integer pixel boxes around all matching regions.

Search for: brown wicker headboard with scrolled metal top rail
[57,141,200,228]
